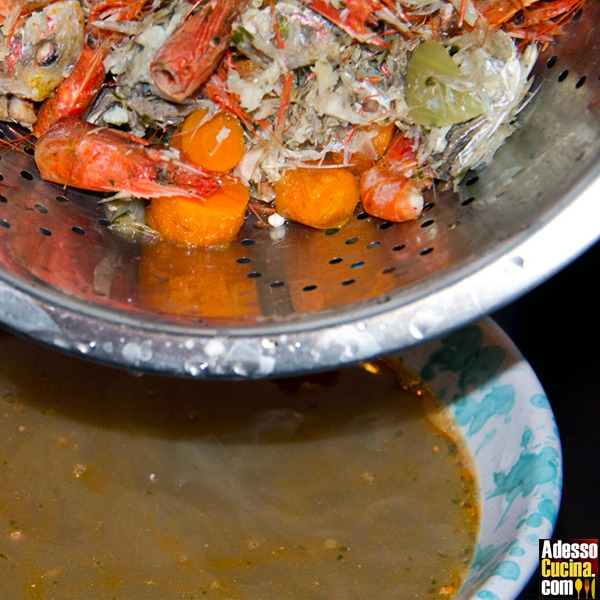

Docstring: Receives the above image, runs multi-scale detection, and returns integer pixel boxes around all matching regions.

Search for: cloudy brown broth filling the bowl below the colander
[0,336,480,600]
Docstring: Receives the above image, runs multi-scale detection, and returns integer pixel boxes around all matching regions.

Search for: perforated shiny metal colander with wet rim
[0,0,600,378]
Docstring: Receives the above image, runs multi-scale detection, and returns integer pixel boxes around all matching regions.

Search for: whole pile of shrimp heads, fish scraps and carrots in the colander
[0,0,584,245]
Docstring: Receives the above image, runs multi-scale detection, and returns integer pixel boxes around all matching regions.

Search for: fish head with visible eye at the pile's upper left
[0,0,84,102]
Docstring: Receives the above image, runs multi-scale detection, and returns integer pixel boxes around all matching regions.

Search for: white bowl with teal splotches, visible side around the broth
[402,319,562,600]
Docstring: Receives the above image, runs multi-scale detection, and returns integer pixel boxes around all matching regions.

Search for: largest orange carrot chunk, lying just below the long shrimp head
[146,181,250,246]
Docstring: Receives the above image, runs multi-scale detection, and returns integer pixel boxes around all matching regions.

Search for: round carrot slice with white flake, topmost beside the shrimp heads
[174,108,244,173]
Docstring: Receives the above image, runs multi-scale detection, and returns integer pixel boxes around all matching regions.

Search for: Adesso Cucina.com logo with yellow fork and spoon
[540,539,598,600]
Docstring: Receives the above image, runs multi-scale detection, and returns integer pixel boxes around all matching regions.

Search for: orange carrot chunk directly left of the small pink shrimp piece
[275,168,360,229]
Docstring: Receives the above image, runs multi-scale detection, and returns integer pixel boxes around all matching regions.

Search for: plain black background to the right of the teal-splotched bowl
[492,241,600,600]
